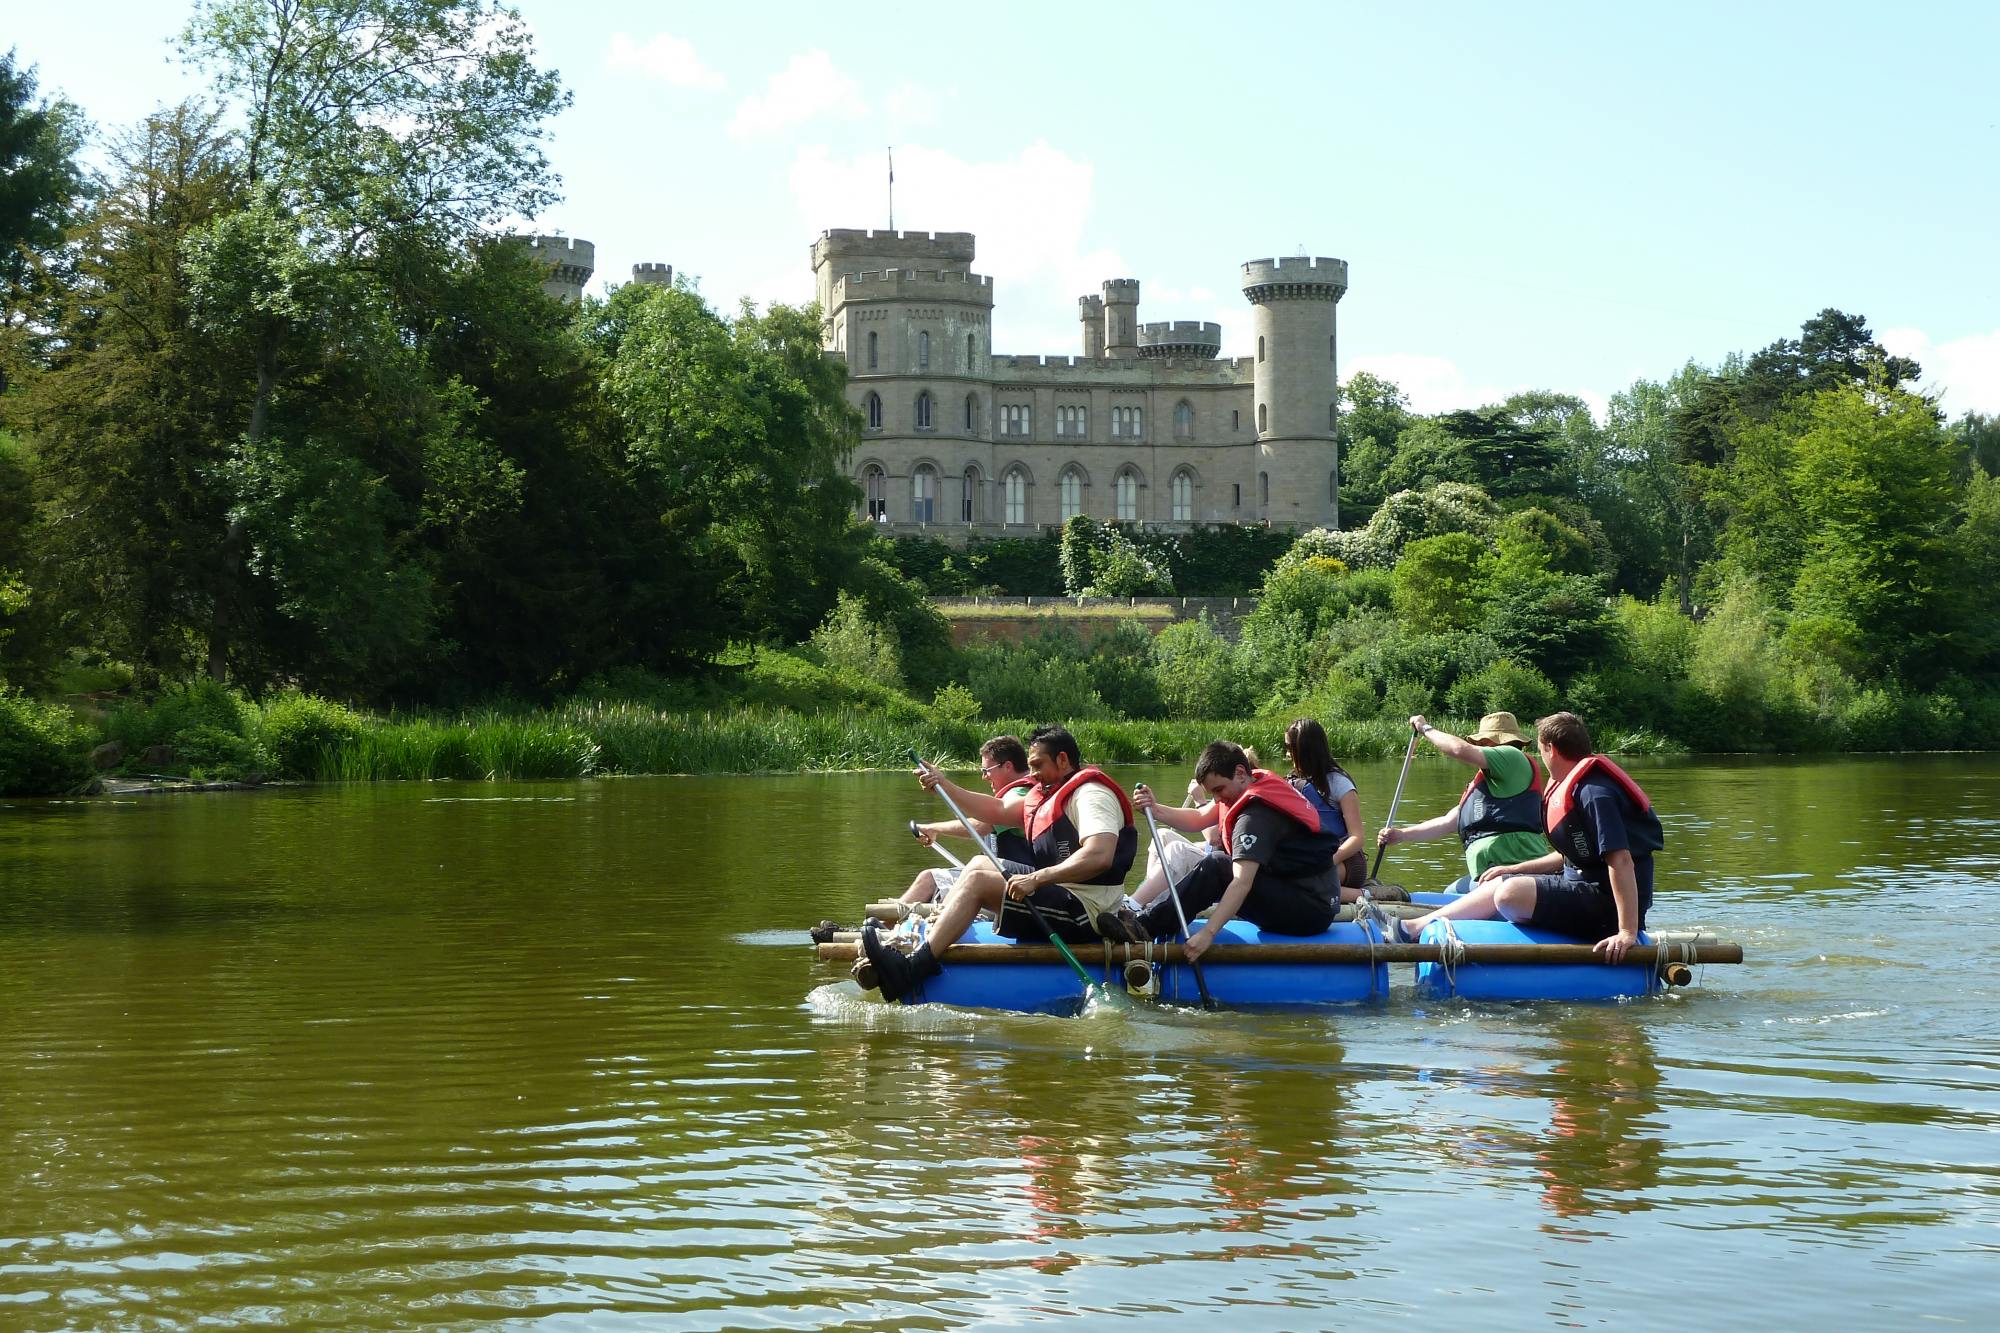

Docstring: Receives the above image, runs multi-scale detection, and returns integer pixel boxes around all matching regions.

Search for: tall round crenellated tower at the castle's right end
[1242,254,1348,526]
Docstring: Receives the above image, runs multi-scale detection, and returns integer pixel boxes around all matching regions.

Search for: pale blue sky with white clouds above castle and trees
[6,0,2000,414]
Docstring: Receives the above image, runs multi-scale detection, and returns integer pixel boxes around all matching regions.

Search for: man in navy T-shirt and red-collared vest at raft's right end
[1400,713,1666,963]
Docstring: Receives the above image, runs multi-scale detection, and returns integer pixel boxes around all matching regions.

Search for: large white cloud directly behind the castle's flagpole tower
[790,142,1128,356]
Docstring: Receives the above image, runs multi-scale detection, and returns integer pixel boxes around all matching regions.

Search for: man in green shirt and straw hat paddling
[1376,713,1548,883]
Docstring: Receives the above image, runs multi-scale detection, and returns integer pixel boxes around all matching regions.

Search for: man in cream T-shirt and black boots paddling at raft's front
[862,727,1138,999]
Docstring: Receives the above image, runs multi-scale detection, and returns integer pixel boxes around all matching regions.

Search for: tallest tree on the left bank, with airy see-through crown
[182,0,566,681]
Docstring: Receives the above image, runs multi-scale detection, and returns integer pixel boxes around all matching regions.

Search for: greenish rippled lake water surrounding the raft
[0,757,2000,1333]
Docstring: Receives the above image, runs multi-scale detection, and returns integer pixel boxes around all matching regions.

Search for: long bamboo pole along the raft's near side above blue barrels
[818,941,1744,967]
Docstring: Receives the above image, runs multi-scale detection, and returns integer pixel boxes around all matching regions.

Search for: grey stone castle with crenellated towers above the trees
[528,230,1348,540]
